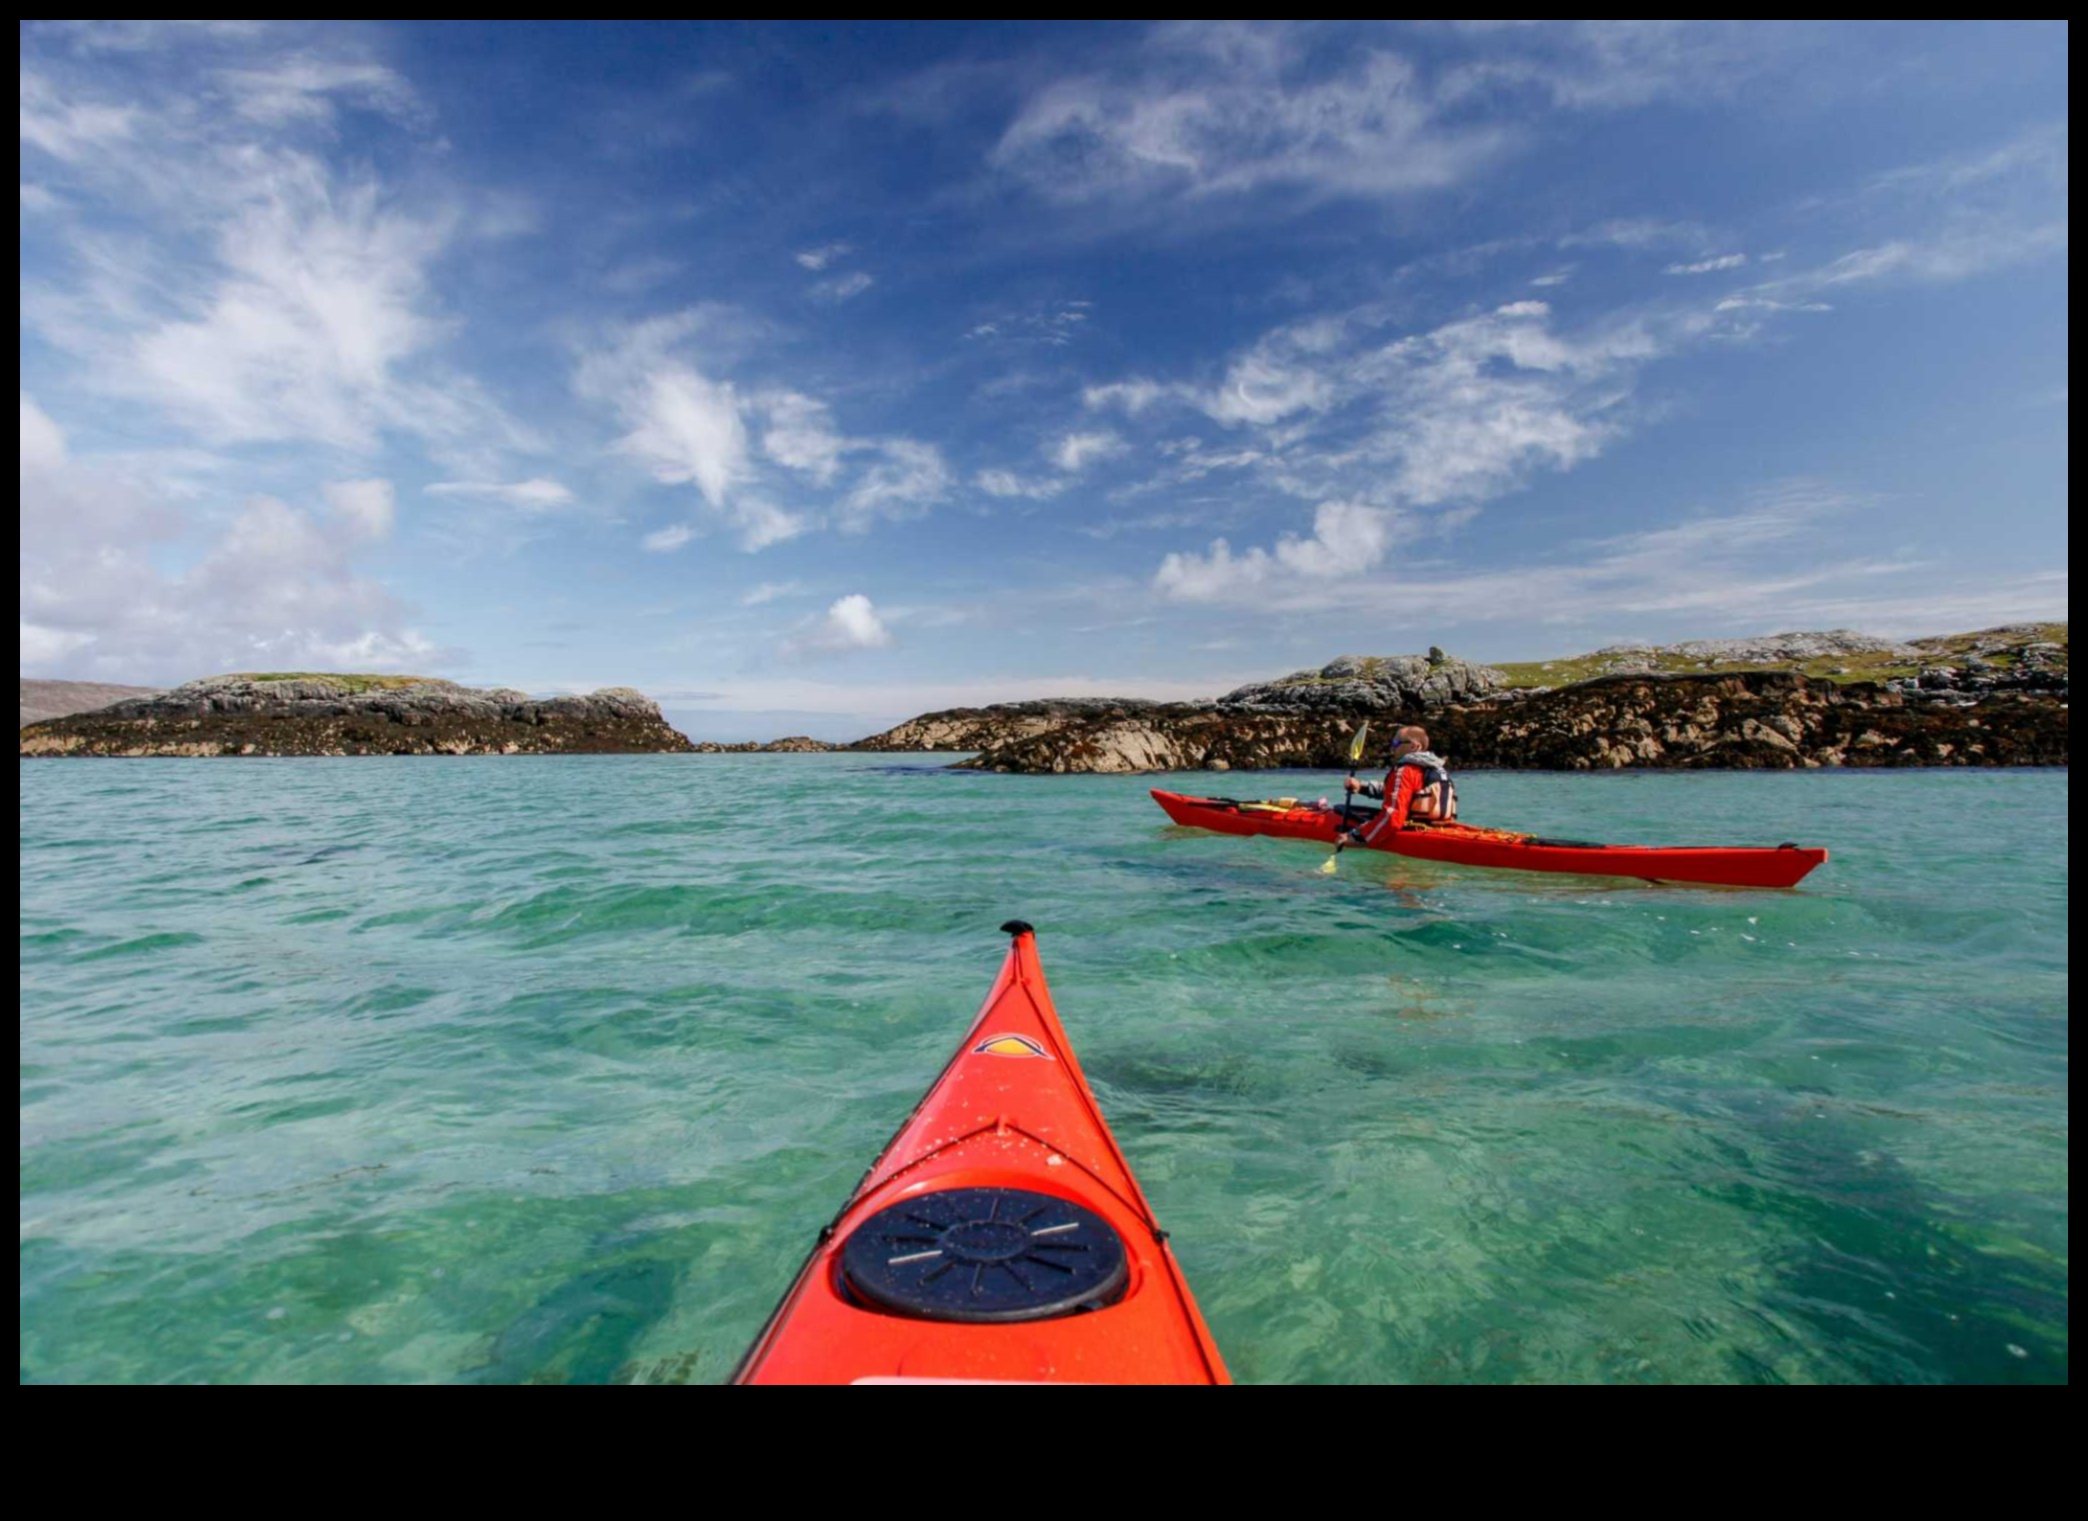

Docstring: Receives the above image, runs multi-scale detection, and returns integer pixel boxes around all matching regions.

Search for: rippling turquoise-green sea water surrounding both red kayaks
[21,756,2067,1383]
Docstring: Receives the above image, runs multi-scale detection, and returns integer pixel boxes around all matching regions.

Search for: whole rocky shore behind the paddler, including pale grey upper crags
[850,625,2067,773]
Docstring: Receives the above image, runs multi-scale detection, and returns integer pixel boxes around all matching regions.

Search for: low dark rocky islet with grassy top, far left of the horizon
[21,673,693,756]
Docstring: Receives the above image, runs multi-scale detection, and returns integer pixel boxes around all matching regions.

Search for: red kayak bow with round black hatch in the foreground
[733,919,1232,1383]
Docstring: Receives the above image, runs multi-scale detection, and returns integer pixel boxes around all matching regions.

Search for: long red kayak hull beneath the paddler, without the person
[1153,788,1827,888]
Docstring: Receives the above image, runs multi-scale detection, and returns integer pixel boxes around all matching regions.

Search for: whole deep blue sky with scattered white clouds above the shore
[21,23,2067,738]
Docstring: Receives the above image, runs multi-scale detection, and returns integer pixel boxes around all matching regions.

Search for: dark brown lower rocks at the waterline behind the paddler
[960,671,2067,771]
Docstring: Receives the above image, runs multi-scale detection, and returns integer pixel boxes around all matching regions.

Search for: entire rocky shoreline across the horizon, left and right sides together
[21,623,2067,775]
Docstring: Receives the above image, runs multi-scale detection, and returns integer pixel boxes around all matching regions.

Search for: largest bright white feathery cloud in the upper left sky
[23,59,537,476]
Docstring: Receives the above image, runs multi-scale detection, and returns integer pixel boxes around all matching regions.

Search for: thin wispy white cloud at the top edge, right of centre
[992,25,1503,203]
